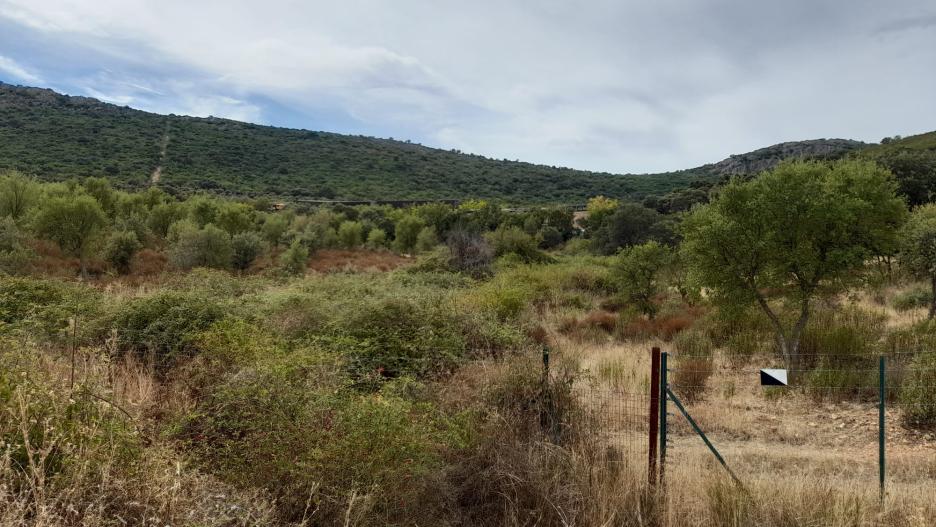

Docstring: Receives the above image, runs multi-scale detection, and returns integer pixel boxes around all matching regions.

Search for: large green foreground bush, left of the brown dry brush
[175,351,444,525]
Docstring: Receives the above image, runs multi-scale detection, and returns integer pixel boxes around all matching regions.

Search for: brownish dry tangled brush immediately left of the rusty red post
[449,358,661,527]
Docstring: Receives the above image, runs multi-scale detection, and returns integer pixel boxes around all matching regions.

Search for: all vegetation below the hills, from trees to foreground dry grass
[0,159,936,527]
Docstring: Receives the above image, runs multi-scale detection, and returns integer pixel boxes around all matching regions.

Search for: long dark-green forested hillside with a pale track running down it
[0,83,876,203]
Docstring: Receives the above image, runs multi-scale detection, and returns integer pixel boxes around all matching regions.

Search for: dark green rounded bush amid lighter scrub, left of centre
[112,291,228,368]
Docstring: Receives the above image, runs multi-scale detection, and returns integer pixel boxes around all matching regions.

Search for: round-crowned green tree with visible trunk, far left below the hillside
[33,195,107,277]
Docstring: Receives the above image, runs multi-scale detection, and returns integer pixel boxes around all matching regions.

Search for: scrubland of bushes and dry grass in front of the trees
[0,251,936,526]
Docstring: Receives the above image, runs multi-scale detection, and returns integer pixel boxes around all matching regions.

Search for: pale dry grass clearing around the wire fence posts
[544,292,936,527]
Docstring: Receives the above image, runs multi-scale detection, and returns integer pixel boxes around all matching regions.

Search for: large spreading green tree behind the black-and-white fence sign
[681,160,906,365]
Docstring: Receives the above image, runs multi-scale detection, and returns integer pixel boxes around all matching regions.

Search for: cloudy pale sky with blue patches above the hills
[0,0,936,173]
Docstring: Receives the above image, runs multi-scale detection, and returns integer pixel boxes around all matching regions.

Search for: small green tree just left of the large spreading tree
[614,240,672,320]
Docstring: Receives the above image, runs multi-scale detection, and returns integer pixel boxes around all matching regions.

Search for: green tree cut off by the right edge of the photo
[900,203,936,318]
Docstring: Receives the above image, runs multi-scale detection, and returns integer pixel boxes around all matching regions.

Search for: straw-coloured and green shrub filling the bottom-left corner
[0,341,179,525]
